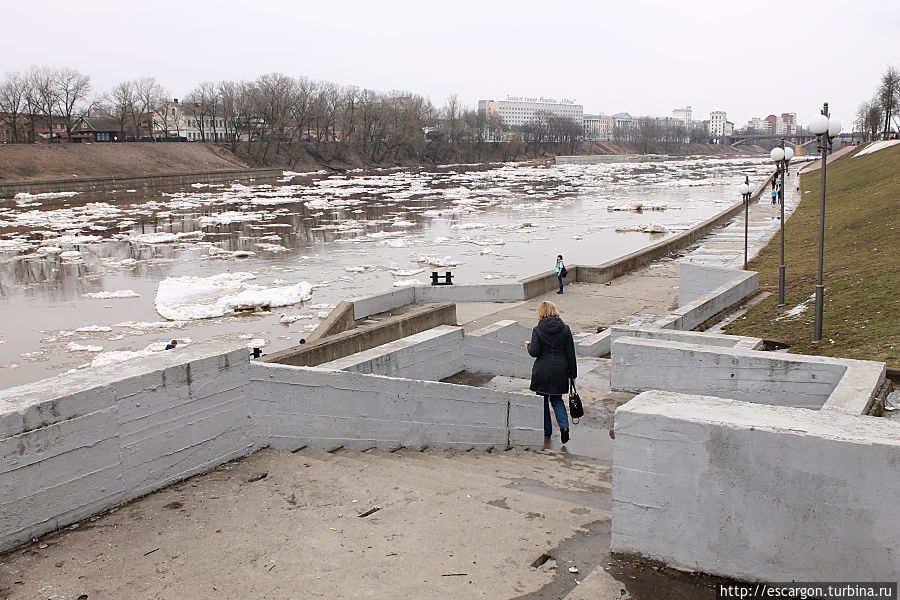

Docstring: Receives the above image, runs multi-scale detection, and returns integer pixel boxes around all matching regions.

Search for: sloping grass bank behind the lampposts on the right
[725,145,900,368]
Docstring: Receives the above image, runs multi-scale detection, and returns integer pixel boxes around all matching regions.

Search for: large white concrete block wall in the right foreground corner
[611,392,900,581]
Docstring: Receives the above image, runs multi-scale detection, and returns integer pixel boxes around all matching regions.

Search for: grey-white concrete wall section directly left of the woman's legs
[250,362,543,450]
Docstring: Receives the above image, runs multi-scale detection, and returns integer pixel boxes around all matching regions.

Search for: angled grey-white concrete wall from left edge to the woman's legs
[0,343,543,551]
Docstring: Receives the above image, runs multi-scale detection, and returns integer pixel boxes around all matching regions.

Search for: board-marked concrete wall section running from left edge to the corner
[0,345,253,550]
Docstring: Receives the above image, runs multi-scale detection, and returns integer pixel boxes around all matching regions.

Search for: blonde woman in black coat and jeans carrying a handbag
[525,300,578,444]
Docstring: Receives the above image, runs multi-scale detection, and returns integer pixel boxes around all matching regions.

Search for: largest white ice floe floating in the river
[156,272,312,321]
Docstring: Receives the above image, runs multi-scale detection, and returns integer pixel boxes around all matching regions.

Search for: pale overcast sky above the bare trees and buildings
[0,0,900,126]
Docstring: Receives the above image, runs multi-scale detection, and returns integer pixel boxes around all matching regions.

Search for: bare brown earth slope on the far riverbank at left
[0,142,247,183]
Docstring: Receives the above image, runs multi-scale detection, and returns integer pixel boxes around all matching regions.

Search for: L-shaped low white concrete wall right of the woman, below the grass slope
[610,337,885,415]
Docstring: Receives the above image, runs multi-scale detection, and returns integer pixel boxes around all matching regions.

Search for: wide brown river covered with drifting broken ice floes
[0,157,770,388]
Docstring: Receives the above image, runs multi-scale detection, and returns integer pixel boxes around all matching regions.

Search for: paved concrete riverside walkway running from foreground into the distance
[0,179,796,600]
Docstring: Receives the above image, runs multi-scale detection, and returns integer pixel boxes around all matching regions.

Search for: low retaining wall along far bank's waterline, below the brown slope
[0,169,284,198]
